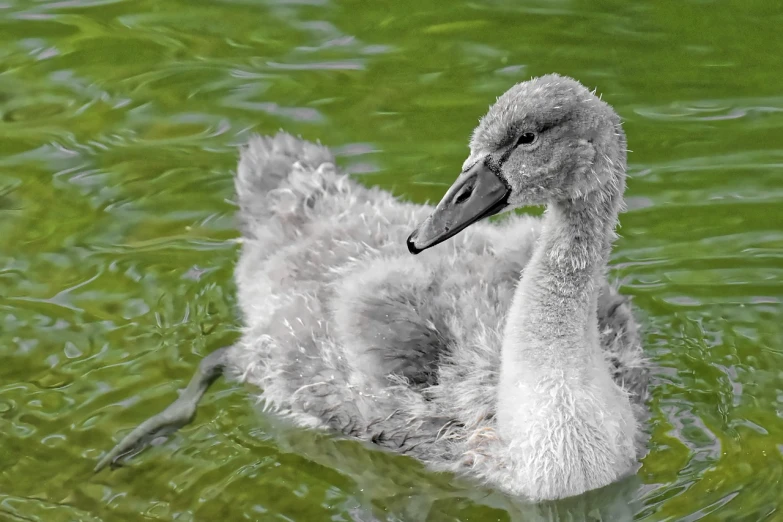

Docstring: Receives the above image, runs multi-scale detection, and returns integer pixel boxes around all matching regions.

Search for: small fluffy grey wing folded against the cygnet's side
[333,254,452,389]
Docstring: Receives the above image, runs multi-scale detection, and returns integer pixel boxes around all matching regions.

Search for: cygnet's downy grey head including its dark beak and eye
[408,74,625,254]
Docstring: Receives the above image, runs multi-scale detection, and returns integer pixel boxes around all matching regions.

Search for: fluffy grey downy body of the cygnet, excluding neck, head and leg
[229,133,647,469]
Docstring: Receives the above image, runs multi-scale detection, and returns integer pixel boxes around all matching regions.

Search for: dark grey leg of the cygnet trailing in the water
[95,347,229,472]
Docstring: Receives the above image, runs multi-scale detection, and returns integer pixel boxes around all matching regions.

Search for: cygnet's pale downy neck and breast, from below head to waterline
[497,170,636,498]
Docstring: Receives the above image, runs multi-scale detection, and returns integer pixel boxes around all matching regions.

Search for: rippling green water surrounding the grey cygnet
[0,0,783,522]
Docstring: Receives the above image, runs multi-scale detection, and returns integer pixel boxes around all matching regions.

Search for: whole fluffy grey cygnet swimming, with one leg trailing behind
[96,75,648,501]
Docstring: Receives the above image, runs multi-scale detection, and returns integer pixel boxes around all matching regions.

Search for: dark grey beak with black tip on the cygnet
[408,157,511,254]
